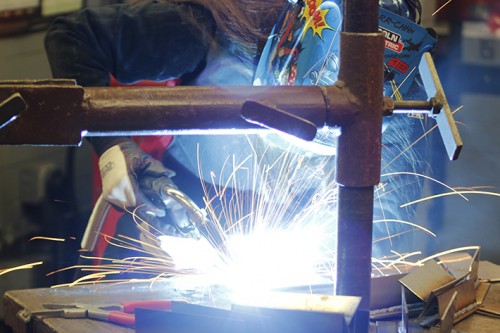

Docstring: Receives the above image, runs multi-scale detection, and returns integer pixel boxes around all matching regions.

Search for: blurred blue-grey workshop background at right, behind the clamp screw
[415,0,500,263]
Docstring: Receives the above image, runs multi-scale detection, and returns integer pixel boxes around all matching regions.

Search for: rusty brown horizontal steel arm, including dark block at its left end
[0,80,364,145]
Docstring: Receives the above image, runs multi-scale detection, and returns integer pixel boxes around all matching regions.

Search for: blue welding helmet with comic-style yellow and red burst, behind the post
[253,0,436,145]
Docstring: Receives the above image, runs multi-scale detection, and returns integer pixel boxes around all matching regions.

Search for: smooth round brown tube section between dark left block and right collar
[84,87,326,136]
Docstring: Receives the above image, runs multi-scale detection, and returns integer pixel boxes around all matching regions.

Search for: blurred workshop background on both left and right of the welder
[0,0,500,331]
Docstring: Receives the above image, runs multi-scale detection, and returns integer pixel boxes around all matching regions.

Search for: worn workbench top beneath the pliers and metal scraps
[3,276,500,333]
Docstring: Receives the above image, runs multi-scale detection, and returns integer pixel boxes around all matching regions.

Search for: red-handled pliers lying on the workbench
[32,300,176,327]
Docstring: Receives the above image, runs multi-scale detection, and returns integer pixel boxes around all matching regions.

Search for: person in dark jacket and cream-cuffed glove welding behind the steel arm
[45,0,426,260]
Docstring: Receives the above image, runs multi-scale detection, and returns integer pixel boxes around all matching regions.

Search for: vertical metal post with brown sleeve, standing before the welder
[335,0,384,333]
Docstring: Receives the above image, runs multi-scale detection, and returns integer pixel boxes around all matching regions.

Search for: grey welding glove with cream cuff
[99,140,175,217]
